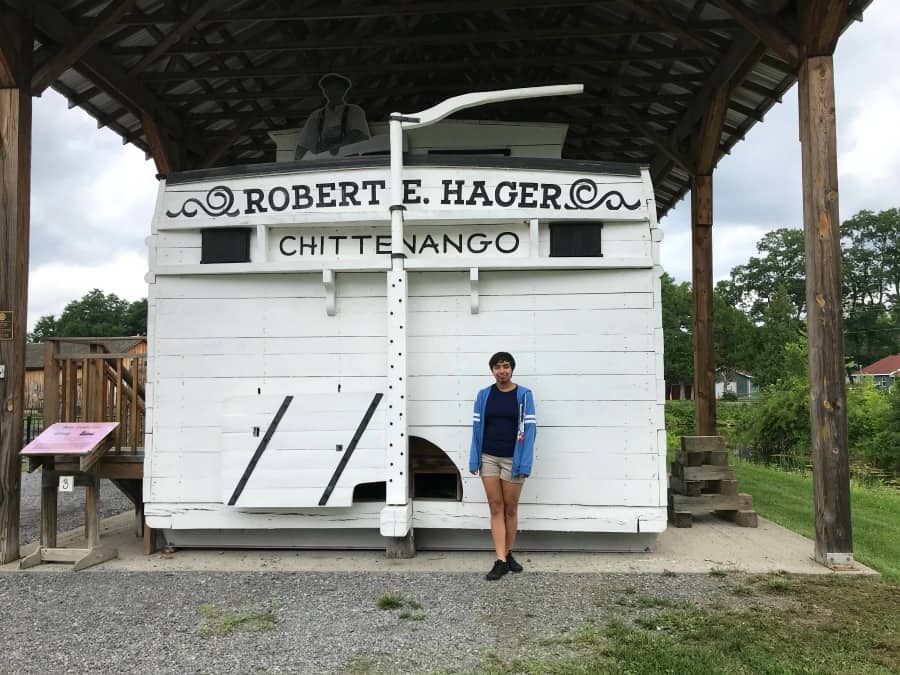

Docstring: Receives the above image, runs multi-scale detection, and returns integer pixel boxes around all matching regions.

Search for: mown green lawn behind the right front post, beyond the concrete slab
[734,461,900,581]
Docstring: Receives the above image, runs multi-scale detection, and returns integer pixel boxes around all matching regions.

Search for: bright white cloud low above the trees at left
[28,251,147,330]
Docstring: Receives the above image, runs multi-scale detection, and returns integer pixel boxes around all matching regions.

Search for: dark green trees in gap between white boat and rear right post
[660,273,694,383]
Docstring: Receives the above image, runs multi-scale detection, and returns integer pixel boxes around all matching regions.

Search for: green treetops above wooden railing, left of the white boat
[29,288,147,342]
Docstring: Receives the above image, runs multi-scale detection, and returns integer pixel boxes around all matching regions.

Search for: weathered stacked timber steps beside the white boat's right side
[669,436,758,527]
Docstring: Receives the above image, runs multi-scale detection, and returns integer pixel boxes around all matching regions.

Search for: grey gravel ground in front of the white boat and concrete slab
[0,572,780,674]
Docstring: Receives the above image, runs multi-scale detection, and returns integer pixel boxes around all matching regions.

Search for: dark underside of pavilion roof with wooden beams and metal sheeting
[10,0,871,215]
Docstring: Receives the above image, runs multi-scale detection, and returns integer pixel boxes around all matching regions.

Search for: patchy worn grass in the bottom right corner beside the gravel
[474,575,900,675]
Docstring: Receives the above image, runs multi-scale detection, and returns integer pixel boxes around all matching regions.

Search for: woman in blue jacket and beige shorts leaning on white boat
[469,352,537,581]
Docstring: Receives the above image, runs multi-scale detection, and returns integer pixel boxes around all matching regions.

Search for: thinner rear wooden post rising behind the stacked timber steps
[691,174,716,436]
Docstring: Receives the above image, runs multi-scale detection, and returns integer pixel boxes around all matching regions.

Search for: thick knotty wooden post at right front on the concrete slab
[799,55,853,564]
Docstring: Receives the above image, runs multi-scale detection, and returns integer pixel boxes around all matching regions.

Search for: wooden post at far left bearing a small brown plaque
[0,3,33,564]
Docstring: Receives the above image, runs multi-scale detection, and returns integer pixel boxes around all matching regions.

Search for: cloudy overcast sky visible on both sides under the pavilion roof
[28,0,900,328]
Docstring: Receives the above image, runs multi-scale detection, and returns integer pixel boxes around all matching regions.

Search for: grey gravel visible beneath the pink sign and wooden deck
[19,471,134,544]
